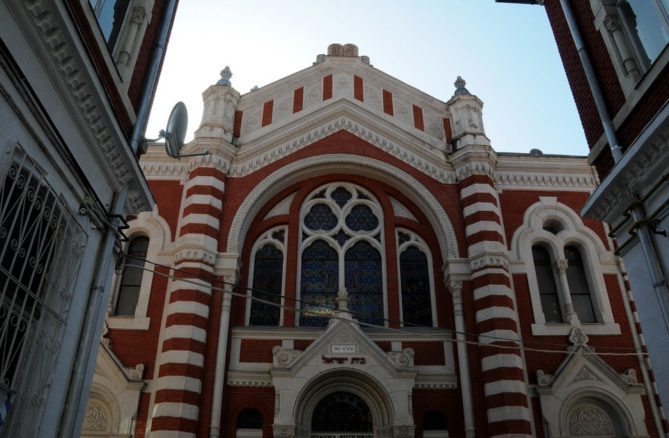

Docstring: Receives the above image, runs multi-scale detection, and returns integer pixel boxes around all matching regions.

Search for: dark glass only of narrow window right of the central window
[400,246,432,326]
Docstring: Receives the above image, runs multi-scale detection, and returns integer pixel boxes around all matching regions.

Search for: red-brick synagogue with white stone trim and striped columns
[94,44,662,438]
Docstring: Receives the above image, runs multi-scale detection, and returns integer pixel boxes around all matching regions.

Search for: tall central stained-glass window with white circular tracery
[300,183,385,326]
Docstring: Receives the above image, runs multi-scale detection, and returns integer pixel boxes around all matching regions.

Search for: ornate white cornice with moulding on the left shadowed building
[7,0,151,211]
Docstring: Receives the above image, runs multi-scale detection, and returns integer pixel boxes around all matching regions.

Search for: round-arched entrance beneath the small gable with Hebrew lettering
[295,370,394,437]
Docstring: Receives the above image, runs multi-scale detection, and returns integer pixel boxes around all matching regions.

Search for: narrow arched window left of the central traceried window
[247,228,286,325]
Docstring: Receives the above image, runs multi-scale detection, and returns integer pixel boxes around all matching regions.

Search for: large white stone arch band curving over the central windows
[227,154,458,259]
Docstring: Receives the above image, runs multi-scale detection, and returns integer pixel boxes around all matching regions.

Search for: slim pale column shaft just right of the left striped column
[209,281,233,438]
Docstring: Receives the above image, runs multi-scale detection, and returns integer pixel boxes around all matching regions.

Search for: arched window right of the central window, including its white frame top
[397,230,434,327]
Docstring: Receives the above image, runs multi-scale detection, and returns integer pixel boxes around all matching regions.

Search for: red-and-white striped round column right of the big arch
[460,174,532,436]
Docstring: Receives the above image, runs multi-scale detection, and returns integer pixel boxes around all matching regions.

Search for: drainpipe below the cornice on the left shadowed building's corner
[59,189,128,438]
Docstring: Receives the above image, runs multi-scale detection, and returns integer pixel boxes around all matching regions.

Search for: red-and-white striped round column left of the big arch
[151,168,225,438]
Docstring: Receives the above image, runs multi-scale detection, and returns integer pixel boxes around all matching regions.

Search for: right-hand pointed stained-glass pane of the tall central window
[345,241,384,325]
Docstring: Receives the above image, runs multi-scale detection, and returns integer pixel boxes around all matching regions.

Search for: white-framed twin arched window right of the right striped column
[512,197,620,335]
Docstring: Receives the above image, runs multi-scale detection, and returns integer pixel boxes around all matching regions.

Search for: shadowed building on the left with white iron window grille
[0,0,176,438]
